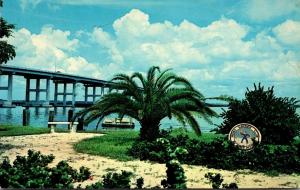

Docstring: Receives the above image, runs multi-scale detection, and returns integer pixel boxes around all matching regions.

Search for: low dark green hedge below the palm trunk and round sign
[129,132,300,173]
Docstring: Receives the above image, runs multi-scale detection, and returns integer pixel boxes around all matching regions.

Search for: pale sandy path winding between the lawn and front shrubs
[0,133,300,188]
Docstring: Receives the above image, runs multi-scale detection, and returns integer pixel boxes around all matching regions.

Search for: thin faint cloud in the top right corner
[244,0,300,22]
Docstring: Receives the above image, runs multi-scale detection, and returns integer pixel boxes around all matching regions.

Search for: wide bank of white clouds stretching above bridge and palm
[6,9,300,98]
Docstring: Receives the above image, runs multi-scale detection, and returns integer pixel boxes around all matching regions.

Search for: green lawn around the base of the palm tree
[74,129,220,161]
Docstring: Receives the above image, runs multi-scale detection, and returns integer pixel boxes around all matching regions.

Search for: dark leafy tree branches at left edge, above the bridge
[0,0,16,65]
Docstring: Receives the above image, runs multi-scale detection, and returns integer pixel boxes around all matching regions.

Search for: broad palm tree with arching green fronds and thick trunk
[76,67,217,140]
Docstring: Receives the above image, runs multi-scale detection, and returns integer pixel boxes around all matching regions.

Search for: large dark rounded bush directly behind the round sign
[217,84,300,144]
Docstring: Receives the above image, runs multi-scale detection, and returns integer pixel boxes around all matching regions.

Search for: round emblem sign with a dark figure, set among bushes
[228,123,261,150]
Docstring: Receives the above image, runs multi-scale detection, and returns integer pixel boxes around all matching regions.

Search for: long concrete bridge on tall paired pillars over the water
[0,65,111,107]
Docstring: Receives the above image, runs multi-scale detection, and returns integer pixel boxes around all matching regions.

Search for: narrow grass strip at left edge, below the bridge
[0,125,50,137]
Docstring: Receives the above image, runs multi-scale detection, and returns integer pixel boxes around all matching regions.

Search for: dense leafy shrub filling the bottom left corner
[0,150,91,188]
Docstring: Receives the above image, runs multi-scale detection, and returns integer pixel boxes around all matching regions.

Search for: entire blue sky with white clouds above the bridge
[1,0,300,99]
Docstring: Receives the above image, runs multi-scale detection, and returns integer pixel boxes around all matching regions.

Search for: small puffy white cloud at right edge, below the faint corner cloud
[273,20,300,46]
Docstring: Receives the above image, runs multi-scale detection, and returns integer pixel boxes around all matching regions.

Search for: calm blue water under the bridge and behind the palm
[0,107,226,132]
